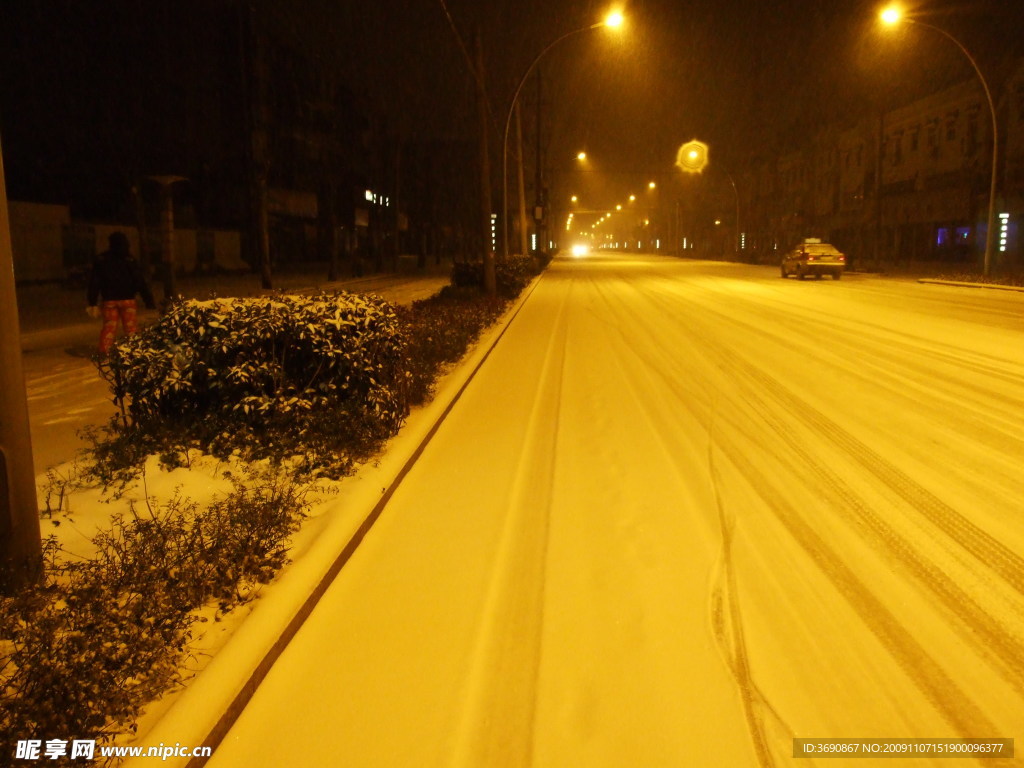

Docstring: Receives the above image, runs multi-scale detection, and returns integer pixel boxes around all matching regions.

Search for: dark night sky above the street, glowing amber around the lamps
[0,0,1024,217]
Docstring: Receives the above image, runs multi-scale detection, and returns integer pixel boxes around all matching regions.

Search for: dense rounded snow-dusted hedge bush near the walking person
[100,293,409,475]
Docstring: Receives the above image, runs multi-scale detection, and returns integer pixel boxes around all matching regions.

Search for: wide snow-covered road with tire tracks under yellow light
[209,256,1024,768]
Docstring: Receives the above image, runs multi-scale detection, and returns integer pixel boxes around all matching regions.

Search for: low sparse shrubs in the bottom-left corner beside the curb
[0,473,307,753]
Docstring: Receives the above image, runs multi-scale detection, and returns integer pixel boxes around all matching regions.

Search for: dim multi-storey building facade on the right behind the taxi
[740,61,1024,271]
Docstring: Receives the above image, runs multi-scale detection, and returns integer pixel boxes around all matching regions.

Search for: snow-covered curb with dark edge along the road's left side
[123,273,543,768]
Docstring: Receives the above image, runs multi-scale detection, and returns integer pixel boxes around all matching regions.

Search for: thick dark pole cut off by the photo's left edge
[0,135,43,594]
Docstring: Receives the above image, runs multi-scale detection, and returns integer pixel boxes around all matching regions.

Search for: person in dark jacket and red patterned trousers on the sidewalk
[86,231,156,355]
